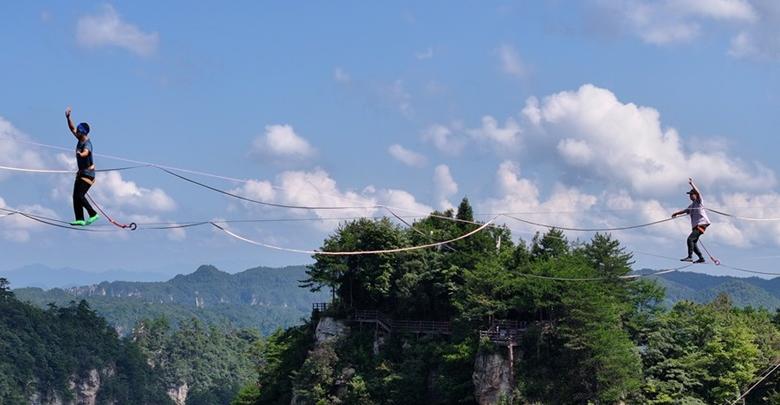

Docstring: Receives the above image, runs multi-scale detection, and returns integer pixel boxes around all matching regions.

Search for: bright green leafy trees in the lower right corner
[643,296,780,404]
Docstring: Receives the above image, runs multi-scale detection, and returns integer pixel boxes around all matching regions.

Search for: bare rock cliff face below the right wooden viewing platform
[471,352,512,405]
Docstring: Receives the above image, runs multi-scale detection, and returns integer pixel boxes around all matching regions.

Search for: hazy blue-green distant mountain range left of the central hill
[10,266,328,334]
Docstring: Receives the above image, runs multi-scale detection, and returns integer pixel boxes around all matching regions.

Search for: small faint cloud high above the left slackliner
[76,4,159,56]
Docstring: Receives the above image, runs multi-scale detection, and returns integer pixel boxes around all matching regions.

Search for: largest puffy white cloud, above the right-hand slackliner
[523,85,776,194]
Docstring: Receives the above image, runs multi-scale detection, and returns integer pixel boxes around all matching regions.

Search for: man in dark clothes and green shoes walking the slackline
[65,107,100,226]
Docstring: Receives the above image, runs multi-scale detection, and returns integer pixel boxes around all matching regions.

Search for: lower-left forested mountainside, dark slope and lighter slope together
[0,278,261,405]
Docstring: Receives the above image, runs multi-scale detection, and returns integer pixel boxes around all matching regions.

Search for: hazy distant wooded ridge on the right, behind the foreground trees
[650,271,780,311]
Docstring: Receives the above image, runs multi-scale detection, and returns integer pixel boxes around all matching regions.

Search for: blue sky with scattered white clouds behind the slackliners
[0,0,780,275]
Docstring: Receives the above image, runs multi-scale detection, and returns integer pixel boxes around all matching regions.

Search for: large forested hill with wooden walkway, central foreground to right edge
[235,200,780,405]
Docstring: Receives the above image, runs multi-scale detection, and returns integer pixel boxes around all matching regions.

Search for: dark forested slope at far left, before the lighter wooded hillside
[0,296,170,404]
